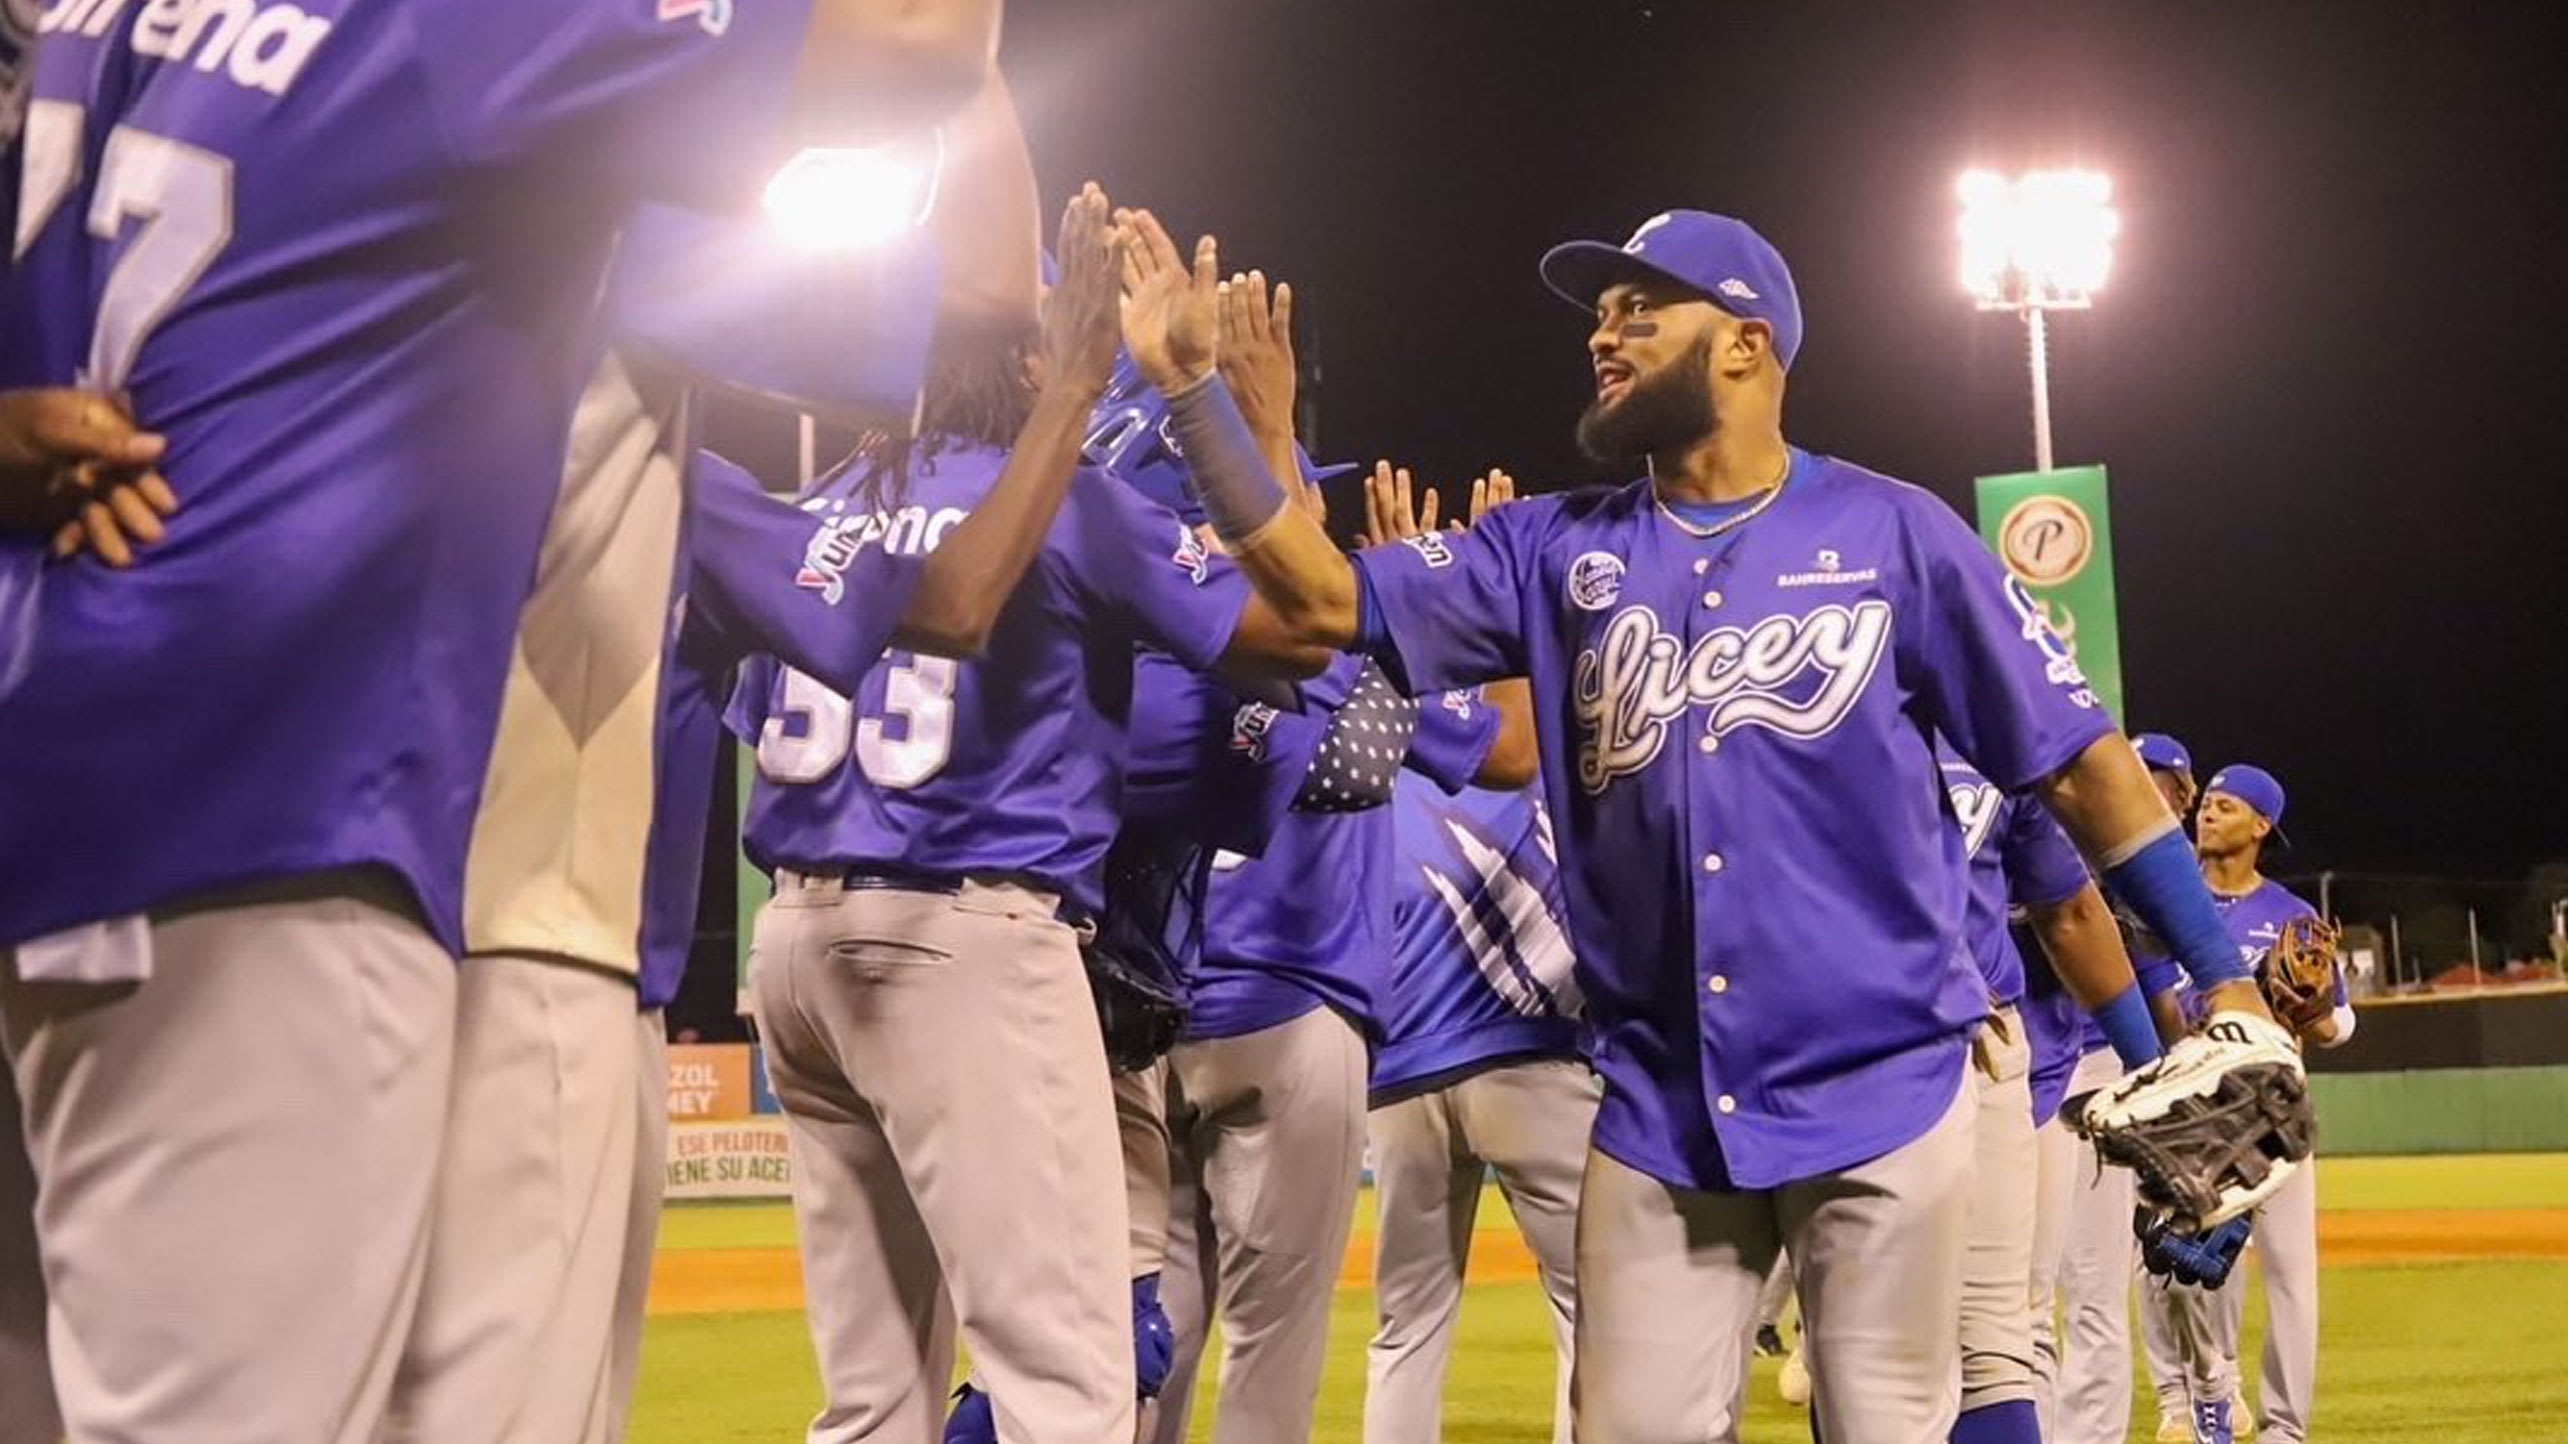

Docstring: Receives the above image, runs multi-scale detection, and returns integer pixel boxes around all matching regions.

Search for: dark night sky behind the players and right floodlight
[734,0,2568,876]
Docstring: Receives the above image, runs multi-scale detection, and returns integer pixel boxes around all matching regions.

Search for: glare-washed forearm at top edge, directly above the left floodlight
[794,0,1002,146]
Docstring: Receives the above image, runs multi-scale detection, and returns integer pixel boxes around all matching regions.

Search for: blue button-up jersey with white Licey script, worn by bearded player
[1358,450,2113,1187]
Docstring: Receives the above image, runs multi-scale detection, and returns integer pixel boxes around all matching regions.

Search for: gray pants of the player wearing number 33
[750,871,1132,1444]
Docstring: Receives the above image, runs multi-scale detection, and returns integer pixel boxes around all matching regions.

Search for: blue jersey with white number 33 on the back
[732,447,1248,912]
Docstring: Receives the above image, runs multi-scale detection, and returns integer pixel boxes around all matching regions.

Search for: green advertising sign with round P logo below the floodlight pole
[1980,465,2124,719]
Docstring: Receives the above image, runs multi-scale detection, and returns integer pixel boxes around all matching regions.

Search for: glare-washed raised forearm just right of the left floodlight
[927,75,1043,337]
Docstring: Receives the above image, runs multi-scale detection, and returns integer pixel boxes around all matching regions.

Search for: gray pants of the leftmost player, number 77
[0,871,455,1444]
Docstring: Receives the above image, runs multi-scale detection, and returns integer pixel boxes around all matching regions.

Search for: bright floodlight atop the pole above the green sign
[1959,170,2121,311]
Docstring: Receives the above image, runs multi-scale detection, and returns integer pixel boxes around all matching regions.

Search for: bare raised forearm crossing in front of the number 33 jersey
[894,383,1097,658]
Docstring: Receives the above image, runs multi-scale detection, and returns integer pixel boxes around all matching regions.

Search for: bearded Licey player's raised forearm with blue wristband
[1168,375,1358,650]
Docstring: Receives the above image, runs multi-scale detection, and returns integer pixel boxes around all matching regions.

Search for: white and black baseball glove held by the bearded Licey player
[2078,1012,2319,1233]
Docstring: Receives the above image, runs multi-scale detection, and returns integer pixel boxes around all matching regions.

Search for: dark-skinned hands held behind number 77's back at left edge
[0,391,177,568]
